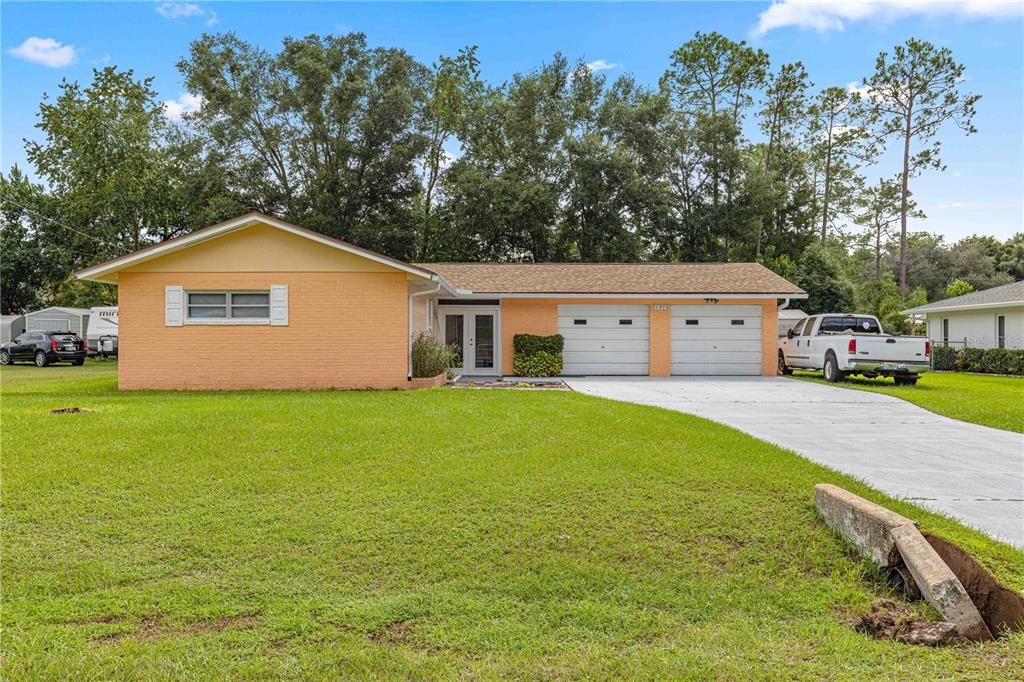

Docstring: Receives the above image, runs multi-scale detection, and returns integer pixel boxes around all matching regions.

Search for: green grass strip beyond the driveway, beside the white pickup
[793,371,1024,433]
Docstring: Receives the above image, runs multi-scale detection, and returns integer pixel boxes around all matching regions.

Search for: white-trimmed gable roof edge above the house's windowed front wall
[75,211,433,282]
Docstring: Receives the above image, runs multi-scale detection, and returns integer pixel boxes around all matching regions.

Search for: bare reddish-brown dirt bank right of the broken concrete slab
[925,534,1024,637]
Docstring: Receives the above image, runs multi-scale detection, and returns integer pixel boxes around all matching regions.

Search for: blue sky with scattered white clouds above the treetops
[6,0,1024,241]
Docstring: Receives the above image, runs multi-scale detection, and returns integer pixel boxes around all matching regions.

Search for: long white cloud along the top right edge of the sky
[754,0,1024,36]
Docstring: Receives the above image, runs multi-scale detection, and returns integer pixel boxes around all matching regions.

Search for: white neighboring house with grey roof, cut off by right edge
[903,282,1024,348]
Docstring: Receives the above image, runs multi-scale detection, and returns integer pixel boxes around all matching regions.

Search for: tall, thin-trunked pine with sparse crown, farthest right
[864,38,981,295]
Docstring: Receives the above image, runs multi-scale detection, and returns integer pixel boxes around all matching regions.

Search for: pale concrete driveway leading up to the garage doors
[565,377,1024,547]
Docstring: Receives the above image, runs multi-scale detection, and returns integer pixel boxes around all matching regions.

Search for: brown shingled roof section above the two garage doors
[411,263,805,297]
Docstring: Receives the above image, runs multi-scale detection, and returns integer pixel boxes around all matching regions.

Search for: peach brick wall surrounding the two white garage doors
[502,298,778,377]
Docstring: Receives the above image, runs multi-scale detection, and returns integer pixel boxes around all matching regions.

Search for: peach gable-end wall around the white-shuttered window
[112,227,410,390]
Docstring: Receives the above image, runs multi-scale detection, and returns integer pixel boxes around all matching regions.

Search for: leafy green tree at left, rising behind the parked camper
[26,67,179,268]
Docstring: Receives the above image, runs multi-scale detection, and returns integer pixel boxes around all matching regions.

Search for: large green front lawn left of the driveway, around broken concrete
[6,363,1024,680]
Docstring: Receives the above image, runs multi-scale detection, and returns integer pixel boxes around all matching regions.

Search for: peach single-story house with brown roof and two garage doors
[77,213,806,389]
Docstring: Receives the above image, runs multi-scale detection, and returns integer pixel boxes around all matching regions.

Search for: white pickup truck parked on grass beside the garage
[778,312,932,384]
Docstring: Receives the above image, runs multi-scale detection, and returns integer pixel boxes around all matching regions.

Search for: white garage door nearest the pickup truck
[672,304,762,375]
